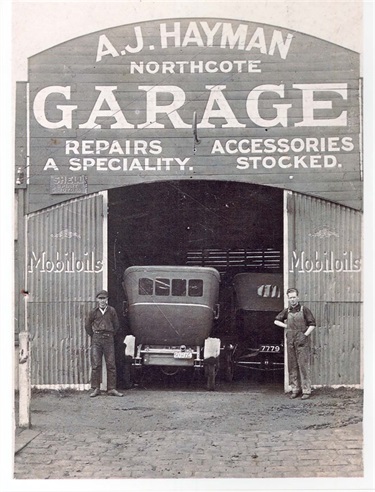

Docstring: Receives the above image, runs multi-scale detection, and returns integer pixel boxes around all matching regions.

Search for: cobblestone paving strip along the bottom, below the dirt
[14,424,363,479]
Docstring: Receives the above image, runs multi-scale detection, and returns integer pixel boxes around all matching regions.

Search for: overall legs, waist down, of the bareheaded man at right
[286,330,311,395]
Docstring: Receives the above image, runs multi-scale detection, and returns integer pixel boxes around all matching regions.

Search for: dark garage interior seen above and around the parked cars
[108,180,283,387]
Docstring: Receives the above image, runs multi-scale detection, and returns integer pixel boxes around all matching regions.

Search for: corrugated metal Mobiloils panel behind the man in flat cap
[27,195,103,387]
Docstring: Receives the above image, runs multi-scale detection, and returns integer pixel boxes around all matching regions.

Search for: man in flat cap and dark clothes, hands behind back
[85,290,123,398]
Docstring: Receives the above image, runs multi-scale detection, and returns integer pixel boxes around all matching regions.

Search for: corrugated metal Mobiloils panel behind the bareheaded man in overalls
[287,192,362,386]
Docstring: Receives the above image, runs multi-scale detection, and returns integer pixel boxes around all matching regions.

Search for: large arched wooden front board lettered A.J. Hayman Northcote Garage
[28,19,362,210]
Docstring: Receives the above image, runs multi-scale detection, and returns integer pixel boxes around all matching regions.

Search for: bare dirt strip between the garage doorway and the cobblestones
[17,372,363,433]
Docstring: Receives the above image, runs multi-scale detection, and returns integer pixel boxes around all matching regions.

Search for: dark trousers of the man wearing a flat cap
[91,333,116,391]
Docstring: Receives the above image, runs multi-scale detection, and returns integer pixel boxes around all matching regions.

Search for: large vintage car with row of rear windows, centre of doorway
[123,266,233,391]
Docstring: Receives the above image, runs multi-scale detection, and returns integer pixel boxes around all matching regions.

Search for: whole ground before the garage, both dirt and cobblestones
[14,378,363,480]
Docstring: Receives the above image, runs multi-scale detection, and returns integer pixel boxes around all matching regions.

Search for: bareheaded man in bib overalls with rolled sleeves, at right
[274,288,316,400]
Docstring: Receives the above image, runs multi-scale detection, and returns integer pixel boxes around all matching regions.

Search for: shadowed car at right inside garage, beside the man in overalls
[233,272,284,371]
